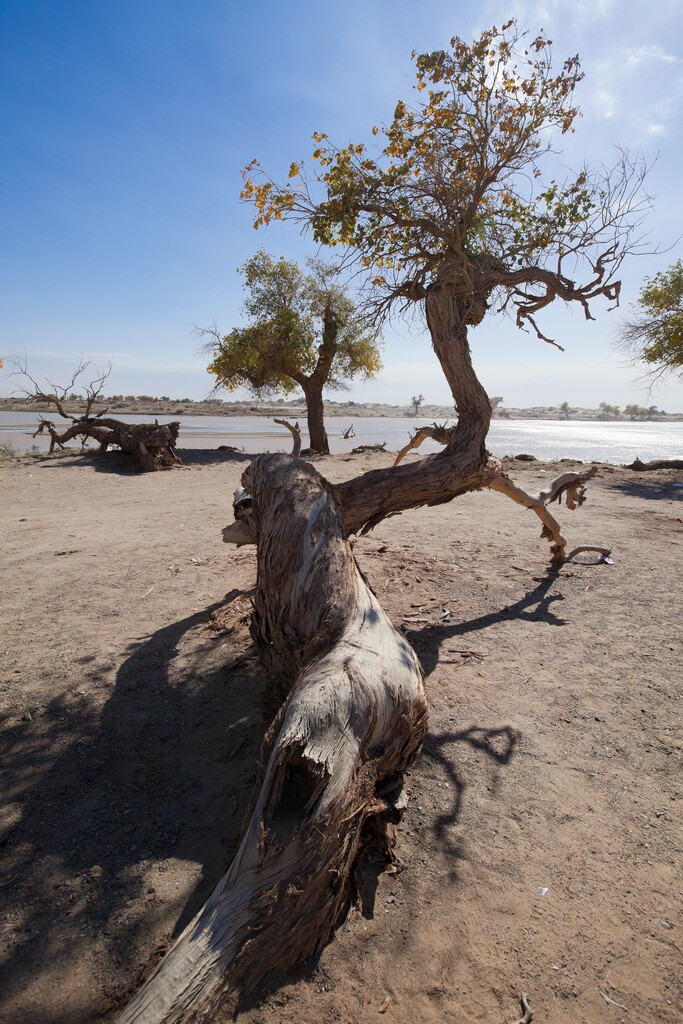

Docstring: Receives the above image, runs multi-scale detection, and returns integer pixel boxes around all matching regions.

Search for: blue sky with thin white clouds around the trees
[0,0,683,412]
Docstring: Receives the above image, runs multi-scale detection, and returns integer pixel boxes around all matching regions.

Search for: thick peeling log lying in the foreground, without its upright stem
[119,455,426,1024]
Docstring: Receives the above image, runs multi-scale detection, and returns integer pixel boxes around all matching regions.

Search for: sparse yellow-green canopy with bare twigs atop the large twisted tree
[242,20,649,341]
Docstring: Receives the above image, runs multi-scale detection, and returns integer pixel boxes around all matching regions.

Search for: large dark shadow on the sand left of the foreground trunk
[0,602,264,1024]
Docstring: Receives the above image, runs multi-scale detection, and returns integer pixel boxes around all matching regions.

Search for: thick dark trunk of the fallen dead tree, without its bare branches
[33,416,182,473]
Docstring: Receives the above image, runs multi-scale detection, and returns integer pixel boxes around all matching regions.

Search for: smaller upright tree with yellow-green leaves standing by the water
[202,250,382,455]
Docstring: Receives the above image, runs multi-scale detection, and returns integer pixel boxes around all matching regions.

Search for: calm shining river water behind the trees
[0,413,683,465]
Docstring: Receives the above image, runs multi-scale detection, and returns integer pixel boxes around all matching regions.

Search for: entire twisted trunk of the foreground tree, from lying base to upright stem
[114,282,606,1024]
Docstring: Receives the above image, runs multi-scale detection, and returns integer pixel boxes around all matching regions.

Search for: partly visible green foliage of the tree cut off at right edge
[618,259,683,376]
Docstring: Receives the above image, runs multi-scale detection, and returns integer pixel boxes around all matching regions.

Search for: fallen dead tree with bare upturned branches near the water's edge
[10,356,181,472]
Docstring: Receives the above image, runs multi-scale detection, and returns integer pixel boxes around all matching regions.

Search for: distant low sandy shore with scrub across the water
[0,395,683,423]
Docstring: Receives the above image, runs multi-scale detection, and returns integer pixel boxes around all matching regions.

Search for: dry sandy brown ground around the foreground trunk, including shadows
[0,452,683,1024]
